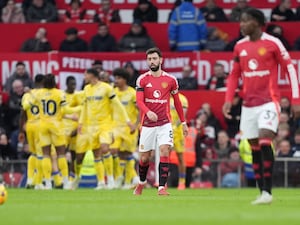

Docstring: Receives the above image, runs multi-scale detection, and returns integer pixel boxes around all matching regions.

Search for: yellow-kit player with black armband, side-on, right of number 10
[74,69,133,190]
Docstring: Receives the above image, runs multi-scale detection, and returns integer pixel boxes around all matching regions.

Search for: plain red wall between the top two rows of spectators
[0,22,300,52]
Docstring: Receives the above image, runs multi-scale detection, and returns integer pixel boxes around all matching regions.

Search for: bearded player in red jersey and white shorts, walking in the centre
[134,48,188,195]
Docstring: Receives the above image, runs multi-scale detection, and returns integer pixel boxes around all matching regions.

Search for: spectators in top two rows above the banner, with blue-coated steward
[0,0,300,52]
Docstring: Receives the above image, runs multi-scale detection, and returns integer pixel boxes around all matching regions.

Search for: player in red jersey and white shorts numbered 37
[223,8,300,205]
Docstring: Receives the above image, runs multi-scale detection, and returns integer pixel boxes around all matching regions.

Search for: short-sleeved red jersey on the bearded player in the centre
[136,71,178,127]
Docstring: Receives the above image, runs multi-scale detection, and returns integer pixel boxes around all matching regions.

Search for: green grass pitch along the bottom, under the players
[0,189,300,225]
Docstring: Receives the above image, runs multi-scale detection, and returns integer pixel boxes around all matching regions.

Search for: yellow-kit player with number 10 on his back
[23,74,80,189]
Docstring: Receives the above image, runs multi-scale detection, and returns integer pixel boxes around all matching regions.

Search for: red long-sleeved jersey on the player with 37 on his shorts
[226,33,300,107]
